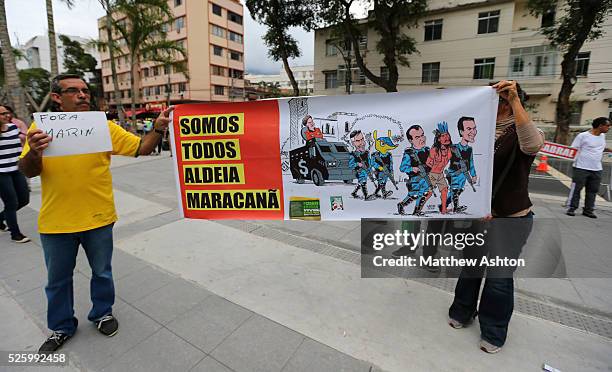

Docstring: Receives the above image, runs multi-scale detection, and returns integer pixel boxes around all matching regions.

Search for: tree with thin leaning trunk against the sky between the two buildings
[246,0,315,96]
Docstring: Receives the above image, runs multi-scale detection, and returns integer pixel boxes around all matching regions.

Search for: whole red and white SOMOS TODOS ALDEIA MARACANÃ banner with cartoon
[171,87,498,220]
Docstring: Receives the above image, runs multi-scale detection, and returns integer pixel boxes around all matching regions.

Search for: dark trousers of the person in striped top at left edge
[0,171,30,237]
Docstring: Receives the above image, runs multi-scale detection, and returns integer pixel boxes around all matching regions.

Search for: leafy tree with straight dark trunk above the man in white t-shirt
[528,0,612,144]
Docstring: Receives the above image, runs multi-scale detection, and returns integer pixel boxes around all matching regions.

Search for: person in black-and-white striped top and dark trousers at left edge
[0,106,30,243]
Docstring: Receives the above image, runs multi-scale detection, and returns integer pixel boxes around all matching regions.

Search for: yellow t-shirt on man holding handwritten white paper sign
[21,121,140,234]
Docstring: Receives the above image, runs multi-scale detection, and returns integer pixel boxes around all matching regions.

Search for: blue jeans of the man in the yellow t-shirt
[40,224,115,335]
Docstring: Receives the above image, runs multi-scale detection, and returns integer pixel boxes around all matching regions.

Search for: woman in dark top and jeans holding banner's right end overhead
[448,80,544,353]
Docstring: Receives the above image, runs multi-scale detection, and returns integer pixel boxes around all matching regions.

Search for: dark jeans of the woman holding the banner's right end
[448,212,533,347]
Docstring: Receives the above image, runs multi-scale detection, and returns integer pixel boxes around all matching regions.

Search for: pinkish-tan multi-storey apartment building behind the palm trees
[98,0,244,110]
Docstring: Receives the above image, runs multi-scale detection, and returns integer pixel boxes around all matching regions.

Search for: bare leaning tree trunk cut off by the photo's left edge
[0,0,30,120]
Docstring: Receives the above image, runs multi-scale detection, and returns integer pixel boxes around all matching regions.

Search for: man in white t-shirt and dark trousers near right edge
[566,117,612,218]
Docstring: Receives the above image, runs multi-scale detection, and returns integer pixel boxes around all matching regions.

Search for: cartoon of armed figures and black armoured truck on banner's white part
[279,88,495,219]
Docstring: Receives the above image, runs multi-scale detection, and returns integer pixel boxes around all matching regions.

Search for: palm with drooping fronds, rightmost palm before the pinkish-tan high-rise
[113,0,186,125]
